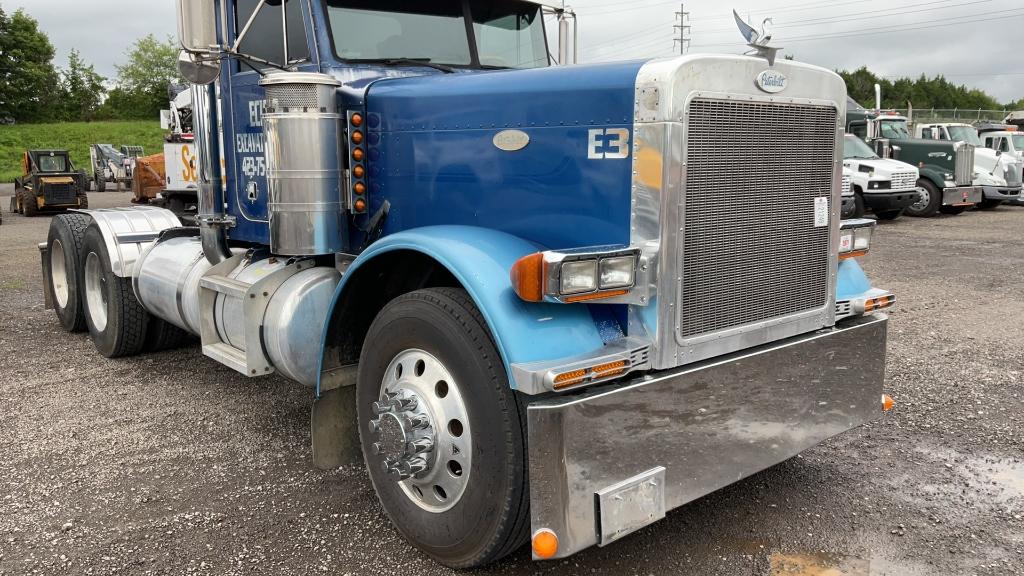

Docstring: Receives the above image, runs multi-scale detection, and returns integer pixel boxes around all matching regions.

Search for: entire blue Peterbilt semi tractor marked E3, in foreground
[41,0,894,568]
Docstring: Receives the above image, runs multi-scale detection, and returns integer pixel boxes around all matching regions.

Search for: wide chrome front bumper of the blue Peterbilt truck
[527,315,888,558]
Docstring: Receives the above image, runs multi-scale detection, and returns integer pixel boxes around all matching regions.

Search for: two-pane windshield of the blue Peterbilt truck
[327,0,549,68]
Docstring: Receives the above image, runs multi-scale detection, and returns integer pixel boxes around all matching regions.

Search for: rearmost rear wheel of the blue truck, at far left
[45,214,91,332]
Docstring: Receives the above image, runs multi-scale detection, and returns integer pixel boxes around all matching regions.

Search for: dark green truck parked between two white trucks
[846,99,983,216]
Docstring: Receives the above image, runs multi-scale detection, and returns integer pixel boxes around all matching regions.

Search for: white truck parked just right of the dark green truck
[914,122,1024,209]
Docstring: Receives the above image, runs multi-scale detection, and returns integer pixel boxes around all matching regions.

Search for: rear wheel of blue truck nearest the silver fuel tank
[82,224,150,358]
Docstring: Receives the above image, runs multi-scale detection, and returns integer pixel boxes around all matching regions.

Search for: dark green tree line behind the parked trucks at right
[839,67,1024,110]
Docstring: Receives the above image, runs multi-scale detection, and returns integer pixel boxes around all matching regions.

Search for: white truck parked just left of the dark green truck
[843,134,921,220]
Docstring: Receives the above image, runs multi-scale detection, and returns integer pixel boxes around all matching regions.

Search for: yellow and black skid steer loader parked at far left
[10,150,89,216]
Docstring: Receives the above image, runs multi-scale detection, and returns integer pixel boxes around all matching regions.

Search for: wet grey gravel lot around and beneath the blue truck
[0,187,1024,576]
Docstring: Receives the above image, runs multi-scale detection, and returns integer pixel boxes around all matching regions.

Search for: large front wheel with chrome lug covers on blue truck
[356,288,529,569]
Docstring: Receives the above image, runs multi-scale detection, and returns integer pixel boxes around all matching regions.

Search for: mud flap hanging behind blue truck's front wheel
[309,386,362,470]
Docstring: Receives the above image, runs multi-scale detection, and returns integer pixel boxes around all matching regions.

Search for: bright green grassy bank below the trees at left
[0,121,164,182]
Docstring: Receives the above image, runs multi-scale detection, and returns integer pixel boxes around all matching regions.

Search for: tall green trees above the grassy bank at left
[0,6,181,123]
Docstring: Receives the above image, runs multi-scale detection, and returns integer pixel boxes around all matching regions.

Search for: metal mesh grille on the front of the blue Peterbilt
[678,98,836,338]
